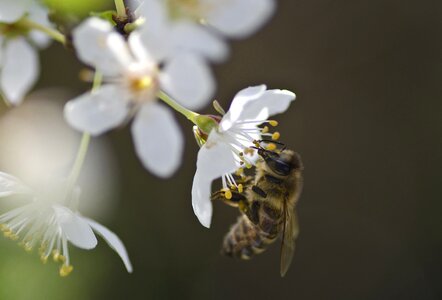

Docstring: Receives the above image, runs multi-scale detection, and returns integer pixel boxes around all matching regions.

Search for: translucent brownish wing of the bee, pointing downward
[280,205,299,277]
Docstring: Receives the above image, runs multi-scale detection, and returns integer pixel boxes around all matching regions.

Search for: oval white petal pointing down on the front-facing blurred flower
[132,103,184,177]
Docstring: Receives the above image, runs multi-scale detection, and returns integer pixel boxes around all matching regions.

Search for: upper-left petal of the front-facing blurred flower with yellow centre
[73,18,132,76]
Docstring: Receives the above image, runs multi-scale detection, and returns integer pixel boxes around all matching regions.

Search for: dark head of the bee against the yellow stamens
[258,148,303,176]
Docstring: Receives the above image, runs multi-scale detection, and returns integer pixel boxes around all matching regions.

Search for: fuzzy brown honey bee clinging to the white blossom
[212,147,303,277]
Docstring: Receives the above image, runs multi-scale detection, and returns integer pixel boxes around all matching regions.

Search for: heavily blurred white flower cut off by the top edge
[133,0,275,61]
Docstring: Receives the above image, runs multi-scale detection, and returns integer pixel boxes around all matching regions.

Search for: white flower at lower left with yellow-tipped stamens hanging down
[0,172,132,277]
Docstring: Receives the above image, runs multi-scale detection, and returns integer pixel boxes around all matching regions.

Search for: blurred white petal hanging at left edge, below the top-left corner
[0,38,40,105]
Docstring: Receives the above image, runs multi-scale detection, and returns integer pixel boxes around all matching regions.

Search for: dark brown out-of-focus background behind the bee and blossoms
[0,0,442,300]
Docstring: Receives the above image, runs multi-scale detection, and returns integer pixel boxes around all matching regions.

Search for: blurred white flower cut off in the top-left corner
[0,0,51,105]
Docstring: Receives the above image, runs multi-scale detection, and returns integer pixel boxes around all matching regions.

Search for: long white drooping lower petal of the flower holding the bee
[192,131,238,228]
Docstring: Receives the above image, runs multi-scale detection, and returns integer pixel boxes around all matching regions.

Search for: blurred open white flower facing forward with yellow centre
[65,18,214,177]
